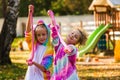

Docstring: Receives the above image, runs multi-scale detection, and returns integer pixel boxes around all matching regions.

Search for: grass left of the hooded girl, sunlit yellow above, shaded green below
[0,51,29,80]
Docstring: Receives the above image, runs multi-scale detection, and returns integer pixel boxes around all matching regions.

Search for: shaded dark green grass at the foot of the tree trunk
[0,63,27,80]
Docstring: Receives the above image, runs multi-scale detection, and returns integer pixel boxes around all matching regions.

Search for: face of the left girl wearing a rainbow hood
[35,25,48,44]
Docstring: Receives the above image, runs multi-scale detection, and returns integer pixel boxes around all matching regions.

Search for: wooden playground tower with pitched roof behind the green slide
[89,0,120,54]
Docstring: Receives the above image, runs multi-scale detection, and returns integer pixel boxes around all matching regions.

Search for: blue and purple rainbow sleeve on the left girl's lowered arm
[41,56,53,70]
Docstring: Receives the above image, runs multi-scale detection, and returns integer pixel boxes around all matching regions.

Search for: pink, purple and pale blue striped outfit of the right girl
[51,26,79,80]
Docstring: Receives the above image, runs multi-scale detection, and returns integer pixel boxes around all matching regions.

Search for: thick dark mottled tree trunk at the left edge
[0,0,19,64]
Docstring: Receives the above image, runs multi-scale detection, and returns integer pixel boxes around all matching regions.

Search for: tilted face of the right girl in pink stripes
[66,30,81,45]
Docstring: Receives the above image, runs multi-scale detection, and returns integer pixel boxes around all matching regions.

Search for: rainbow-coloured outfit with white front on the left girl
[25,22,54,80]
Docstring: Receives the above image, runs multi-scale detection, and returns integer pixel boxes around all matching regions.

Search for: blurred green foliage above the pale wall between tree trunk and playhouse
[19,0,92,17]
